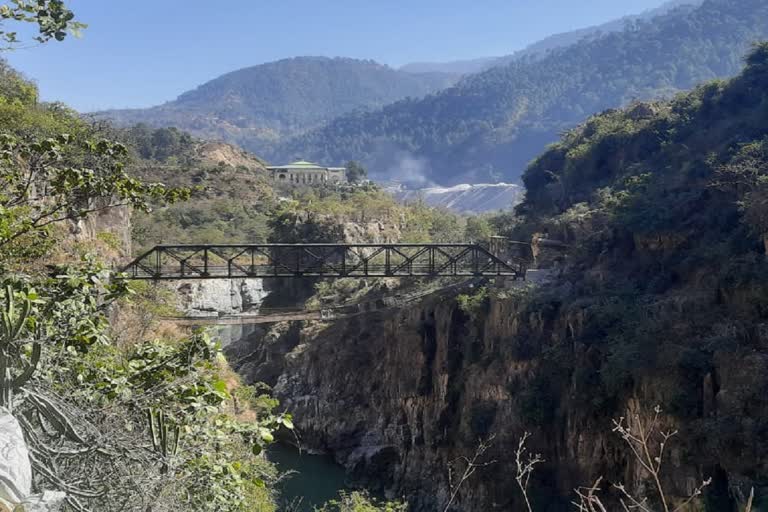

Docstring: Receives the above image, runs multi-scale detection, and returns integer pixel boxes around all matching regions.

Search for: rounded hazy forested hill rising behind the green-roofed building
[97,57,458,153]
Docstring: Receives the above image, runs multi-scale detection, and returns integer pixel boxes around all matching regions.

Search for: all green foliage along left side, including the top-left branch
[0,11,292,512]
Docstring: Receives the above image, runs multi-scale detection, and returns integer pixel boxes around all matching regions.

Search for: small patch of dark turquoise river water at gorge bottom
[267,444,346,512]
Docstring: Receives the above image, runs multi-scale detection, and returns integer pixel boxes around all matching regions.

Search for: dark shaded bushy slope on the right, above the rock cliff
[500,43,768,511]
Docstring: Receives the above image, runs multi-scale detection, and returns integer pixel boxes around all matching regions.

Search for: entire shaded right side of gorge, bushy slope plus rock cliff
[165,45,768,510]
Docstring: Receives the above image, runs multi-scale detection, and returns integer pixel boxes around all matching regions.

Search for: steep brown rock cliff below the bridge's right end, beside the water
[231,285,766,511]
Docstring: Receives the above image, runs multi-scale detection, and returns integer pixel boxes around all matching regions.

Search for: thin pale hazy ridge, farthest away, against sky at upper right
[399,0,704,75]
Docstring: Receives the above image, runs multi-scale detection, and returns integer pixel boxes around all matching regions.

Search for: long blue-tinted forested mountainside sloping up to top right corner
[274,0,768,184]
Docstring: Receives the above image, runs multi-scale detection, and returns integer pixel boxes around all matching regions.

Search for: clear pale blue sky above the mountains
[7,0,663,111]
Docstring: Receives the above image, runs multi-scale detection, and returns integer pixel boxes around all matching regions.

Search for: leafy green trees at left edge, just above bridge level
[0,134,189,263]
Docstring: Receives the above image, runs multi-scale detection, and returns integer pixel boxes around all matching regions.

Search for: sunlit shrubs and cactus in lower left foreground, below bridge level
[4,264,292,511]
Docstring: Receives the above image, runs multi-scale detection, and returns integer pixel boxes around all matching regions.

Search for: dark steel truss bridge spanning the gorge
[122,244,526,280]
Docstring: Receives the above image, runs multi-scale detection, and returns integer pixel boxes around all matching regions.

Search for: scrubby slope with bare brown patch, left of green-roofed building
[119,125,277,253]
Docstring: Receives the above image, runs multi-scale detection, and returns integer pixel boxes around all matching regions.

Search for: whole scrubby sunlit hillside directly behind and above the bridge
[122,121,500,253]
